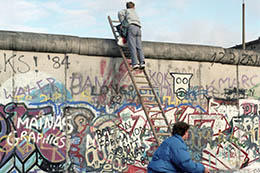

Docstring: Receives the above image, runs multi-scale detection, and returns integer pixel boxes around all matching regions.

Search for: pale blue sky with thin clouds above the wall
[0,0,260,48]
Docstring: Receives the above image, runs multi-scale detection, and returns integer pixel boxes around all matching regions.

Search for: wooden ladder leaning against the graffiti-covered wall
[108,16,171,146]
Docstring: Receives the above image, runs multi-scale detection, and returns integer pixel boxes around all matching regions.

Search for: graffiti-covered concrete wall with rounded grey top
[0,31,260,173]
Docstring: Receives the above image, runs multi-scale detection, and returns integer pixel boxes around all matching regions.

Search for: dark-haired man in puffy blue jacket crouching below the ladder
[148,122,210,173]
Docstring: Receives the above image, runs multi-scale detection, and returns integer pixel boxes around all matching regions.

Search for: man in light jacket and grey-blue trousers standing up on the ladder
[118,2,145,70]
